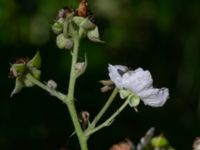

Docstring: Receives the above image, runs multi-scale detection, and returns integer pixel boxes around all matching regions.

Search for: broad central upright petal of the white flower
[122,68,153,93]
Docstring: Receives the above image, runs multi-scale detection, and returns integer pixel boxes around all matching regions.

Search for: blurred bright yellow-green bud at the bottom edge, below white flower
[151,135,169,148]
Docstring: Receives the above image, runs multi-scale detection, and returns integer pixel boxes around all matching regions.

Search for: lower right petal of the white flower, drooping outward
[138,88,169,107]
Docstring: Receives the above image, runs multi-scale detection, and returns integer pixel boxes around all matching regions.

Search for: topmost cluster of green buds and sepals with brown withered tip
[52,0,102,49]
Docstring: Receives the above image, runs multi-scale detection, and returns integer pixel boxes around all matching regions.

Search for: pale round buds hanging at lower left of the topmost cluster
[56,34,73,49]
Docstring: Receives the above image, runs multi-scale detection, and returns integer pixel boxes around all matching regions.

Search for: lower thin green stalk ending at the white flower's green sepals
[86,100,129,136]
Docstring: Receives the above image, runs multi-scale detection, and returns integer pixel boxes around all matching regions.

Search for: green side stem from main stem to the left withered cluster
[26,74,67,103]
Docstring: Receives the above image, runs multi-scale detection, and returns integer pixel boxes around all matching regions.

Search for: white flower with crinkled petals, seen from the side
[108,65,169,107]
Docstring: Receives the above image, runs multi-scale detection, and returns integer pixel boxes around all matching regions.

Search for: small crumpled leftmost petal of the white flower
[108,64,128,88]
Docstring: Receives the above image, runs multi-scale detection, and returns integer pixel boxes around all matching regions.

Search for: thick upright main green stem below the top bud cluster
[66,37,88,150]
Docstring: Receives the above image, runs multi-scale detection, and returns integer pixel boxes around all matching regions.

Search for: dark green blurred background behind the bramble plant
[0,0,200,150]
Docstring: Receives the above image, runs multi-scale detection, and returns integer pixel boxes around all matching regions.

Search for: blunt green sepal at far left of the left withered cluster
[11,64,26,77]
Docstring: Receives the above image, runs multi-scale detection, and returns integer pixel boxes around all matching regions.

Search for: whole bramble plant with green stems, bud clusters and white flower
[10,0,172,150]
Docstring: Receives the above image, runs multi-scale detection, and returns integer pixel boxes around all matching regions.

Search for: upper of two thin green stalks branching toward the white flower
[89,88,118,130]
